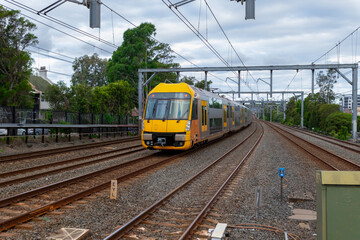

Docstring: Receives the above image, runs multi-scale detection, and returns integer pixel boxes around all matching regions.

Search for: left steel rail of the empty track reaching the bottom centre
[104,123,257,240]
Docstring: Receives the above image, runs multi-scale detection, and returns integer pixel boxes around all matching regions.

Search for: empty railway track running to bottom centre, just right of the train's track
[105,124,263,240]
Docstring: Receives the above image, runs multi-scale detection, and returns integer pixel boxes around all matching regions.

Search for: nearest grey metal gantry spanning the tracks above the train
[138,63,358,140]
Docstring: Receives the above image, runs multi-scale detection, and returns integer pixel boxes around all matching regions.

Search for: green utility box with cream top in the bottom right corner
[316,171,360,240]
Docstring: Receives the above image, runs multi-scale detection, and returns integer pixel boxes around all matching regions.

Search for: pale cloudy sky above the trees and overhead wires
[0,0,360,100]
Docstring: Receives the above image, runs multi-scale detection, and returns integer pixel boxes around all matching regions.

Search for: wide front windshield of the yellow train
[145,93,191,120]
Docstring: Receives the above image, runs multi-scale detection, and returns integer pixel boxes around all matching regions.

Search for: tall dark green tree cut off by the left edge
[0,6,38,107]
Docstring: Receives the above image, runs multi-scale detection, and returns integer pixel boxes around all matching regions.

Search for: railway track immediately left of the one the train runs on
[0,145,145,187]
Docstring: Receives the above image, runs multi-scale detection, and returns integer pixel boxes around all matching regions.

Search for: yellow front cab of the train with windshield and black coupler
[142,83,196,150]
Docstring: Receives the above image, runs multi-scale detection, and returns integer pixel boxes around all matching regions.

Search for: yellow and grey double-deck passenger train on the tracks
[141,83,252,150]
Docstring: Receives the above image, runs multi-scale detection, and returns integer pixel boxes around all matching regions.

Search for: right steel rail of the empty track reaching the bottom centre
[179,124,264,240]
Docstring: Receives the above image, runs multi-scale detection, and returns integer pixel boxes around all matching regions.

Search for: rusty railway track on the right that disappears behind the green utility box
[265,122,360,171]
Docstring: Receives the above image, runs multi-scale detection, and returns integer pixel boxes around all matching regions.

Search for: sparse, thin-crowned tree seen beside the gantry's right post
[316,69,337,103]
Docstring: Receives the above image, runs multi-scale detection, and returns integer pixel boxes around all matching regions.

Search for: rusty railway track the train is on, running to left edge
[0,124,252,231]
